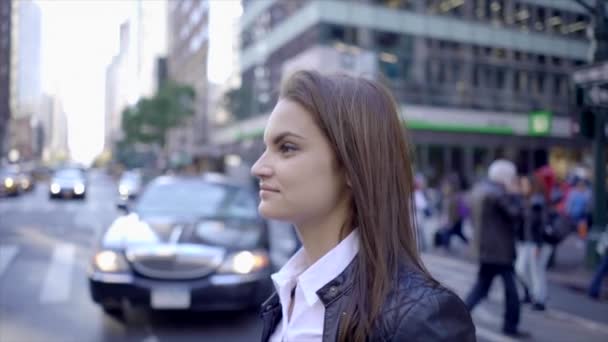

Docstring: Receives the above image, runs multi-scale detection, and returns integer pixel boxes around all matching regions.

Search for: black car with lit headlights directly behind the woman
[89,176,272,314]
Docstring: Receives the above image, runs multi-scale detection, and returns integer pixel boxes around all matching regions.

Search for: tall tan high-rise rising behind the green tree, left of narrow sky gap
[166,0,209,166]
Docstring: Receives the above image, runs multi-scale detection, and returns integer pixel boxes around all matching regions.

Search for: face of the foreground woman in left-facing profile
[251,99,349,224]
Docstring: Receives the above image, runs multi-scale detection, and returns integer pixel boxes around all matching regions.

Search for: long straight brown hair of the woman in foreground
[280,71,432,341]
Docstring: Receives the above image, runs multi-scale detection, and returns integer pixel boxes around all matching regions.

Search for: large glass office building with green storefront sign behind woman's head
[213,0,590,181]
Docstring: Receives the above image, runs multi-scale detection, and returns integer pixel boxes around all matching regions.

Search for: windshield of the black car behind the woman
[134,180,258,219]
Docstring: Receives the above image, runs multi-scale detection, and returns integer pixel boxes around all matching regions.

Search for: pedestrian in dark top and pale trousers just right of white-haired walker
[515,175,553,311]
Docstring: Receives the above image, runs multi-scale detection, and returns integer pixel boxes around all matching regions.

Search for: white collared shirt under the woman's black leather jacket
[270,229,359,342]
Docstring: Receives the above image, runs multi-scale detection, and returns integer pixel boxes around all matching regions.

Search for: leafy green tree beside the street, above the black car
[122,82,196,148]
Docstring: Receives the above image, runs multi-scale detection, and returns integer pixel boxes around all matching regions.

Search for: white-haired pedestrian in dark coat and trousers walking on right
[465,159,528,337]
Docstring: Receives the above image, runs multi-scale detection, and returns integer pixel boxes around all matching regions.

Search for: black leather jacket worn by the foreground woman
[261,258,476,342]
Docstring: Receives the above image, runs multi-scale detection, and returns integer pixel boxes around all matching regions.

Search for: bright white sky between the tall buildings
[36,0,240,164]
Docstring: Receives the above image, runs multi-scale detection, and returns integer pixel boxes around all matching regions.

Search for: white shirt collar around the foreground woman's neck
[271,229,359,306]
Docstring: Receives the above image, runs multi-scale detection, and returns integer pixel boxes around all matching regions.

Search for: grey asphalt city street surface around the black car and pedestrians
[0,171,608,342]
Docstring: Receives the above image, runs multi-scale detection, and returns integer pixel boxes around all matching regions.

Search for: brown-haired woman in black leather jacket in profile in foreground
[252,71,475,341]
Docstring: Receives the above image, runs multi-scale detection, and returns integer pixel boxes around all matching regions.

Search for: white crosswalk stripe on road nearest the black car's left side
[40,244,76,303]
